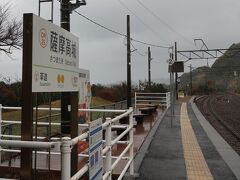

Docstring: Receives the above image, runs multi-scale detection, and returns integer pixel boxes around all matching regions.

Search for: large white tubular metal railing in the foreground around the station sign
[0,104,134,180]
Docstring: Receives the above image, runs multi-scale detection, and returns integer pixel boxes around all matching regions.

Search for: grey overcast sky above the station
[0,0,240,84]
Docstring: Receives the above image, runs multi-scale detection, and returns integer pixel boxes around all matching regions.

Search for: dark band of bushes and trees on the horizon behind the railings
[0,78,167,106]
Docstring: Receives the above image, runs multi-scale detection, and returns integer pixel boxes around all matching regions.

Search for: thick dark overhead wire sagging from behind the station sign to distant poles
[74,10,170,49]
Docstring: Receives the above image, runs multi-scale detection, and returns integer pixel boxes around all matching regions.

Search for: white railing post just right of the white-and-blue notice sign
[105,118,112,180]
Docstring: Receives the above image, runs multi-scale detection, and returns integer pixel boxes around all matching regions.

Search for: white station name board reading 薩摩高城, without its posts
[32,15,79,92]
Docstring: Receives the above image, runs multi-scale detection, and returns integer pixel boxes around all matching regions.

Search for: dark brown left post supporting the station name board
[20,14,33,180]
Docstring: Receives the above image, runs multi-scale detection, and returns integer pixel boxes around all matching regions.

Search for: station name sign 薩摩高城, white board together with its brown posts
[21,14,79,180]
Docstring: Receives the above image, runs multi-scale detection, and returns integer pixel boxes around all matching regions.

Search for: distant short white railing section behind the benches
[135,92,171,109]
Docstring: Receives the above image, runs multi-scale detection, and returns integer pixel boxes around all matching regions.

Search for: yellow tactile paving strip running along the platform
[180,103,213,180]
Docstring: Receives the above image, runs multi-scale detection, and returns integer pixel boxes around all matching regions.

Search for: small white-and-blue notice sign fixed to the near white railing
[89,118,103,180]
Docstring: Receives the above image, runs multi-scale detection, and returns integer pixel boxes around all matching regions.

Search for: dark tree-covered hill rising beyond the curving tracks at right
[180,43,240,94]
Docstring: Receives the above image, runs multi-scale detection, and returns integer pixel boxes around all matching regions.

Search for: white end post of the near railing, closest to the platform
[129,107,134,175]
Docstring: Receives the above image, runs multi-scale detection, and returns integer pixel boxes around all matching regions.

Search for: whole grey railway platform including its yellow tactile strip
[131,98,240,180]
